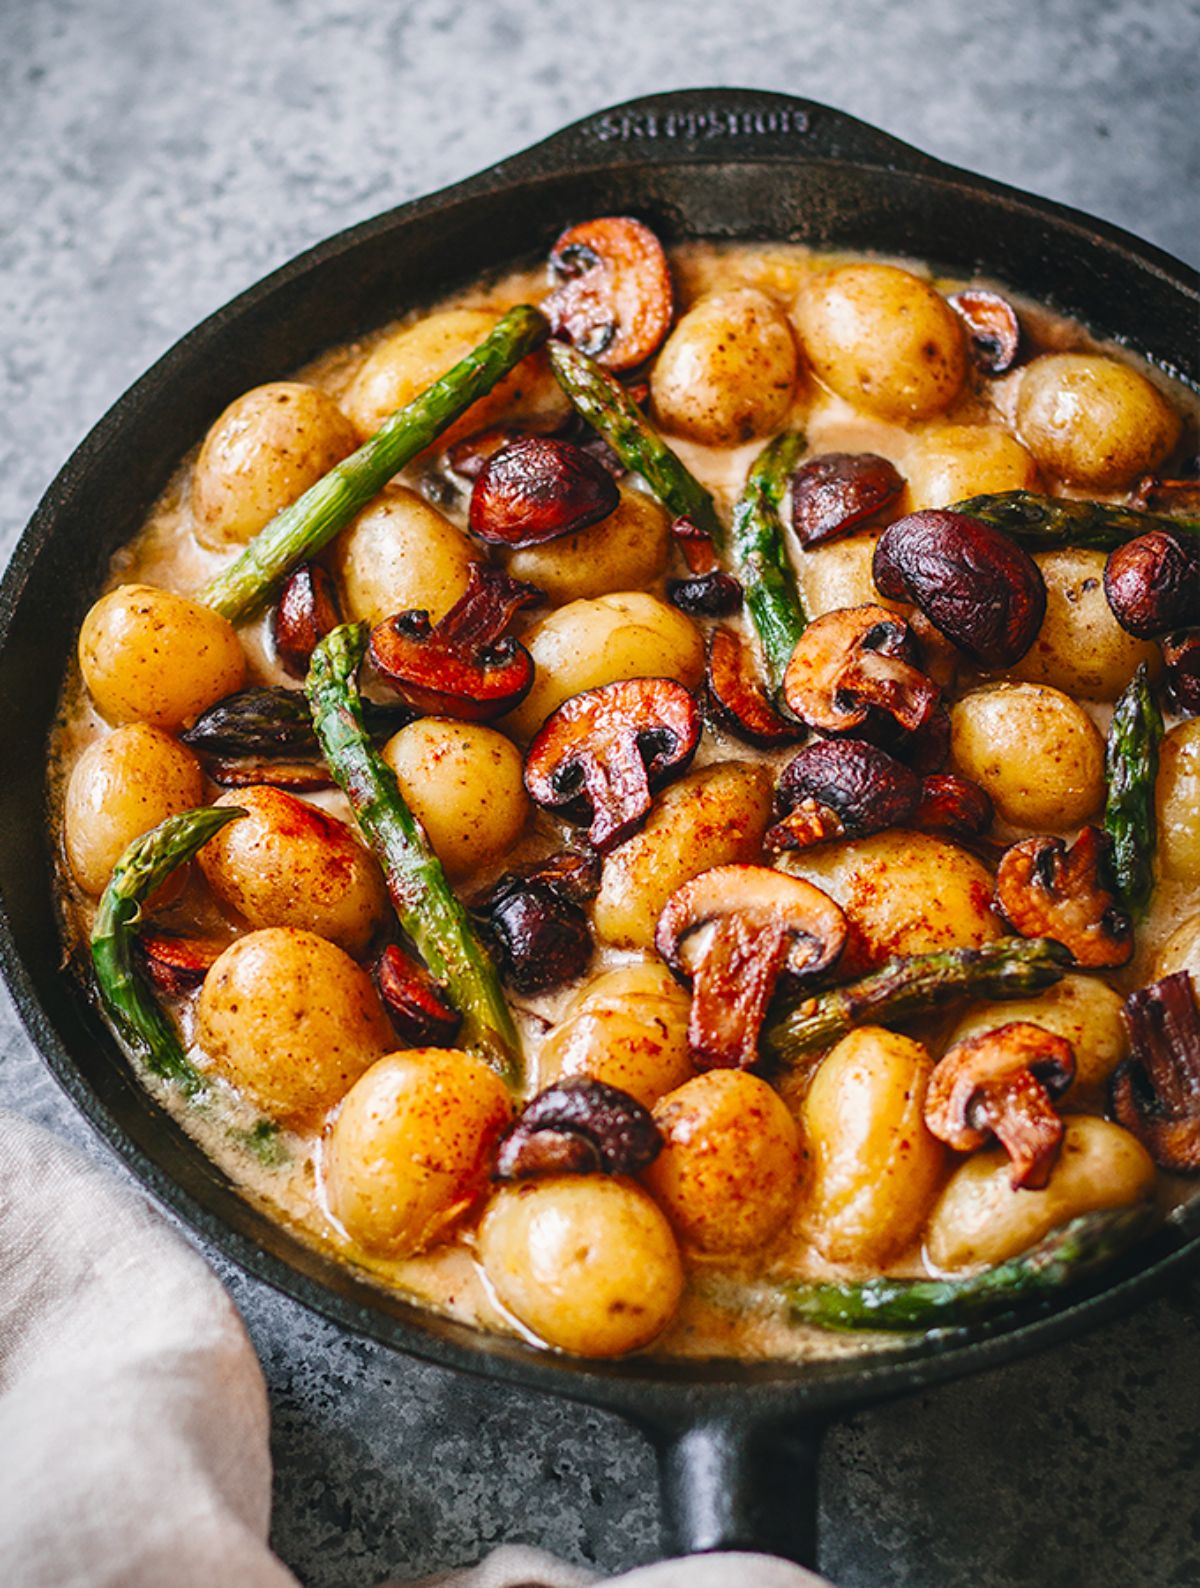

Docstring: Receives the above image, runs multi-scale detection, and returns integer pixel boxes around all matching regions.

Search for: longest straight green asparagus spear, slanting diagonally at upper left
[200,303,549,621]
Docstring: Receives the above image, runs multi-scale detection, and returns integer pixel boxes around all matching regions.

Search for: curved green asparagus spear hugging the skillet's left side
[92,805,246,1097]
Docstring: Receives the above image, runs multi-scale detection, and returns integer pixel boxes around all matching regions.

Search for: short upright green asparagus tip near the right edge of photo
[1105,662,1162,916]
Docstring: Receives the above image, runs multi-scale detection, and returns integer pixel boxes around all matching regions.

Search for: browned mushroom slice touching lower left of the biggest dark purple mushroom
[784,605,940,734]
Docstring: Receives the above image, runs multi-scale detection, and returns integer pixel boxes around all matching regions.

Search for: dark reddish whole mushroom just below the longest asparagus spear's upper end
[468,435,621,549]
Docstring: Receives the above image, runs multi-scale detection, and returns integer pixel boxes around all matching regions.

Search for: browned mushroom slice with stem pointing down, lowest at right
[925,1019,1075,1191]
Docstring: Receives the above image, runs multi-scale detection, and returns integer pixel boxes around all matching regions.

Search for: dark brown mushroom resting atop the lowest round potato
[494,1077,662,1180]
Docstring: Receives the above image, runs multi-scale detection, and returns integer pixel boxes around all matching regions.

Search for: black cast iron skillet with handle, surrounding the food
[0,89,1200,1561]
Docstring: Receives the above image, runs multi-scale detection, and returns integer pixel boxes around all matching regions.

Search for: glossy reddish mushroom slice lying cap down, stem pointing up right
[370,562,541,723]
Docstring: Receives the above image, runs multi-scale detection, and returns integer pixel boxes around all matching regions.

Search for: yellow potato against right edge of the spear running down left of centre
[383,716,530,881]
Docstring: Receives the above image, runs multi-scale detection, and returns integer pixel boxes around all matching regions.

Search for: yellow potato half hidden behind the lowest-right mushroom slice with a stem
[946,975,1129,1113]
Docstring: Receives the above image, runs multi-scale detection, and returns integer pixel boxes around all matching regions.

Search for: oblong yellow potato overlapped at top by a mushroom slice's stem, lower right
[925,1113,1157,1272]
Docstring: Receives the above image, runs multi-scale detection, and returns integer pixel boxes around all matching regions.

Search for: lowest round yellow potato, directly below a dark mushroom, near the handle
[479,1175,684,1356]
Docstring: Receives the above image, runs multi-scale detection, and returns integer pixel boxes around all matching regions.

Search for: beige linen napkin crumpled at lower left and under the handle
[0,1110,822,1588]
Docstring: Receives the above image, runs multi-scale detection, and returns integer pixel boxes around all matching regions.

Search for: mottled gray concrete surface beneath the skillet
[0,0,1200,1588]
